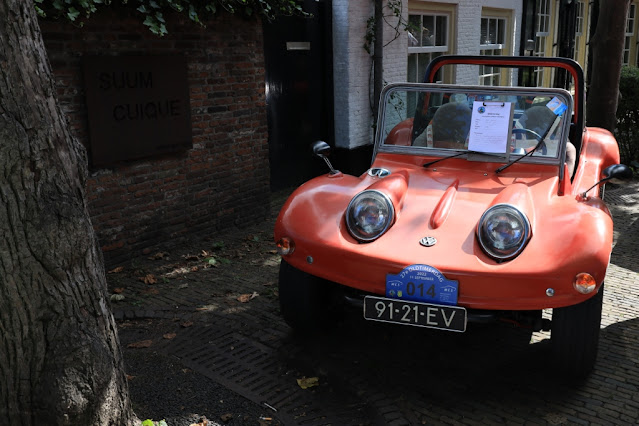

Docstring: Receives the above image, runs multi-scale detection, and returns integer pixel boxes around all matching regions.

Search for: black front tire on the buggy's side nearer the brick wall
[279,260,330,333]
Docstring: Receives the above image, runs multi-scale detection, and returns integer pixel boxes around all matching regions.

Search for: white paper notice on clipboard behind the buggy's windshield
[468,101,513,154]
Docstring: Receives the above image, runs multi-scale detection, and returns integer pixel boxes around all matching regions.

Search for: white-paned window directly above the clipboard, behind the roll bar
[479,17,506,86]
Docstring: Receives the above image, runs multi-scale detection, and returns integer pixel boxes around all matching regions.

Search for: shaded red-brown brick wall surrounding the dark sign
[41,9,270,266]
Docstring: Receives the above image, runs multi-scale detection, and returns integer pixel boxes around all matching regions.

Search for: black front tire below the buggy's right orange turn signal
[550,285,604,378]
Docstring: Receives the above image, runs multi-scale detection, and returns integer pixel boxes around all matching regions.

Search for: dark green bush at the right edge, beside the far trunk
[615,66,639,164]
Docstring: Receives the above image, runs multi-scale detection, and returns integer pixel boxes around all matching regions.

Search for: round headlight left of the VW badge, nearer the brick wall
[346,189,395,242]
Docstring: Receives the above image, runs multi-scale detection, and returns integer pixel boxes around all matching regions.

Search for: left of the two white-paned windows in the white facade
[407,14,449,83]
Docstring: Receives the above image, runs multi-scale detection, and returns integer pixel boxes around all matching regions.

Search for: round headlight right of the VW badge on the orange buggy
[477,204,530,260]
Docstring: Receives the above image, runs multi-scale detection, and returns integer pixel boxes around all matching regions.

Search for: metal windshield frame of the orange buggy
[372,83,574,179]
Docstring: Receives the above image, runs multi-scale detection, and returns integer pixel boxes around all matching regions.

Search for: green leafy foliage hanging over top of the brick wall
[35,0,307,36]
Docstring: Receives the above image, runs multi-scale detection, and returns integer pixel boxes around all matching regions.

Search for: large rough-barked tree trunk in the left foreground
[0,0,132,426]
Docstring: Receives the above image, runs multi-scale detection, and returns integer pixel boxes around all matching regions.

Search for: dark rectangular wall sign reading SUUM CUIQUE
[84,56,193,166]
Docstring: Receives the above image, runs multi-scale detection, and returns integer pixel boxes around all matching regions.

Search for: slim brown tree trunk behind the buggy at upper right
[586,0,630,132]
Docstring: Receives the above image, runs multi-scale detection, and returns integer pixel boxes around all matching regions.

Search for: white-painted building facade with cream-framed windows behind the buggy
[333,0,522,150]
